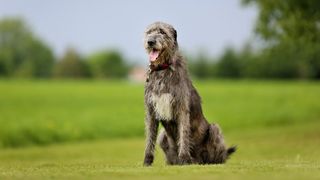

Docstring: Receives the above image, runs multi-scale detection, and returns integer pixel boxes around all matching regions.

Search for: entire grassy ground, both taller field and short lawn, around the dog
[0,80,320,179]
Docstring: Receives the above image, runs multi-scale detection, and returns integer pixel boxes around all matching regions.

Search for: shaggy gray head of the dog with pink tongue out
[144,22,178,65]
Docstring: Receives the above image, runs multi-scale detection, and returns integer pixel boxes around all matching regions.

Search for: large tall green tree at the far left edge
[0,18,54,77]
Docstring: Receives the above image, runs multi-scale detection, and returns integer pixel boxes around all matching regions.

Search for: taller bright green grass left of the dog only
[0,81,144,147]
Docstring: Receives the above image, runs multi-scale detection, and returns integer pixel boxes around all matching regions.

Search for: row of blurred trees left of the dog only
[0,18,129,78]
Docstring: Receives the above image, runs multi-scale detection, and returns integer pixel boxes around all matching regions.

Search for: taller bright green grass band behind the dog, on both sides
[0,80,320,147]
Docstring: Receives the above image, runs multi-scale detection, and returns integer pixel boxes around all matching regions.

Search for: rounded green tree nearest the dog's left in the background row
[88,50,128,78]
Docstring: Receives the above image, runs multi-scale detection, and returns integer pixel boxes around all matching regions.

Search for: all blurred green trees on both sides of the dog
[0,0,320,79]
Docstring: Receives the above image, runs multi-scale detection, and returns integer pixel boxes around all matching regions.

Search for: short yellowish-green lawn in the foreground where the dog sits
[0,123,320,180]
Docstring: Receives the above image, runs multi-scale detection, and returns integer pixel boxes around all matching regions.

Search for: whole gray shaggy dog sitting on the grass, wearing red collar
[144,22,236,166]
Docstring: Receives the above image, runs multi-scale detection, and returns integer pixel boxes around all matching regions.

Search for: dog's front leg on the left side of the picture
[143,110,159,166]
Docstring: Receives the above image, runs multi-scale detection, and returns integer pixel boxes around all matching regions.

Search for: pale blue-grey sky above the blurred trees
[0,0,257,63]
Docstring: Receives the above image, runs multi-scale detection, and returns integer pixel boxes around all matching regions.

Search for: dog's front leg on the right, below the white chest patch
[178,112,192,164]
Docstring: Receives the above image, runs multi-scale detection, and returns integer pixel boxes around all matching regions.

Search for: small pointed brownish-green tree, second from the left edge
[54,48,90,78]
